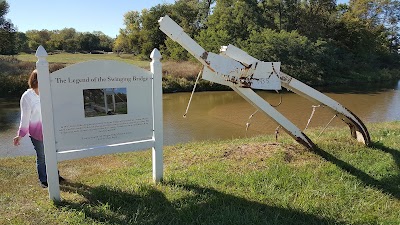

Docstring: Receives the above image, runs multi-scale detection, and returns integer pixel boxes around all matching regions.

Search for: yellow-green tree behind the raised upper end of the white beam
[113,0,215,60]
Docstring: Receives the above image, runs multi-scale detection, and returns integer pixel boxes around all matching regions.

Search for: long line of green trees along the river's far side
[0,0,400,84]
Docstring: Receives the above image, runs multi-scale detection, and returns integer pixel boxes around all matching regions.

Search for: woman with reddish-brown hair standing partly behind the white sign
[13,70,64,188]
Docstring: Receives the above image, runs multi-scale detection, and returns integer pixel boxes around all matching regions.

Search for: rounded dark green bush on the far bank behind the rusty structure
[240,29,398,85]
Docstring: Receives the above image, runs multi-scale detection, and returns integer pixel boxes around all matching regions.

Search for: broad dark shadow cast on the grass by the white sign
[58,181,344,225]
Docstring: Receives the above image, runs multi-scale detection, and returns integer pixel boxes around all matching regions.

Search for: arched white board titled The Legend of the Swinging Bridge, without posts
[50,61,153,152]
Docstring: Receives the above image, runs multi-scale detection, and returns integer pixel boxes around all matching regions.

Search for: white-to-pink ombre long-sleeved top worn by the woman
[18,89,43,141]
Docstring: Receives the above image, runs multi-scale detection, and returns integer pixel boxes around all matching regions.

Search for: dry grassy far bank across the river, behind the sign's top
[0,53,229,97]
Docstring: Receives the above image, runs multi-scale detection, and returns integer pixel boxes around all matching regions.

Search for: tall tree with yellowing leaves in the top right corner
[340,0,400,68]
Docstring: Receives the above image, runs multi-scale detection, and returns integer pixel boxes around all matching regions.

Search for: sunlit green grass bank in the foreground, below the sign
[0,122,400,224]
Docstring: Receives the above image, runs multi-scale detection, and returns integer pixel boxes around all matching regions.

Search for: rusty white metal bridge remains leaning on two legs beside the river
[159,15,371,150]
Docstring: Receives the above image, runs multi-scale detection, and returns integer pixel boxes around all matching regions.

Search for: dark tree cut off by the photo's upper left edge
[0,1,17,55]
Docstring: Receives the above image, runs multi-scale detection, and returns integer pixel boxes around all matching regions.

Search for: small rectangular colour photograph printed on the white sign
[83,88,128,117]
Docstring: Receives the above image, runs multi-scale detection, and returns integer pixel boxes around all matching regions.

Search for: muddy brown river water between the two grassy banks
[0,81,400,157]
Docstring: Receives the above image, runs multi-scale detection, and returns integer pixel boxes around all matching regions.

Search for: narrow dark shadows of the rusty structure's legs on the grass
[314,142,400,199]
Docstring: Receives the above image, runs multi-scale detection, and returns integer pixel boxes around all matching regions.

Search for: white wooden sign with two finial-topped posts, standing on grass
[36,46,163,200]
